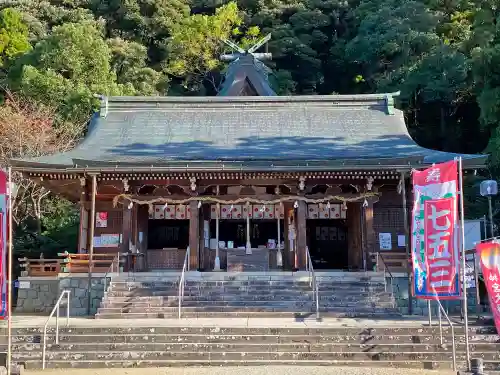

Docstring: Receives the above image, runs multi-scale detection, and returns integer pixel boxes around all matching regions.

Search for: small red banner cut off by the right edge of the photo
[476,241,500,334]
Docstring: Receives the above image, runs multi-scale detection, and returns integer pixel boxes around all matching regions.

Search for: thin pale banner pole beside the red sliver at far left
[6,167,13,375]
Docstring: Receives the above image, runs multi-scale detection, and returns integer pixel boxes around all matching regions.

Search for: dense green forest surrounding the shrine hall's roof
[0,0,500,256]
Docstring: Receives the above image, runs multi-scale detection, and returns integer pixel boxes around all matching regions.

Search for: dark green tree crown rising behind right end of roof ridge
[346,0,440,92]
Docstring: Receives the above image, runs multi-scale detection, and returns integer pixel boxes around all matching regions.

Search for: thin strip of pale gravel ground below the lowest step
[24,366,453,375]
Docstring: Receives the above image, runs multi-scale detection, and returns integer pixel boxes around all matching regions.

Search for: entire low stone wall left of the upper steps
[15,275,109,316]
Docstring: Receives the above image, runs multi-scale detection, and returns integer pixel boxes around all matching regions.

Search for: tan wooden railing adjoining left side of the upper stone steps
[57,252,119,273]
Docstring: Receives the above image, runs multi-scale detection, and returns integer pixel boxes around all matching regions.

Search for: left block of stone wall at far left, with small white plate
[14,277,59,314]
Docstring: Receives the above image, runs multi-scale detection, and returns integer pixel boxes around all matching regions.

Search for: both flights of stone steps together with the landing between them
[8,272,500,374]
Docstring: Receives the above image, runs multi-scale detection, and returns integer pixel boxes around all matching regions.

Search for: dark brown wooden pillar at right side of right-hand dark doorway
[347,202,363,270]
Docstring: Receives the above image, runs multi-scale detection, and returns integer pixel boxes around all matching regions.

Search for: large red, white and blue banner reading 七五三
[411,161,462,299]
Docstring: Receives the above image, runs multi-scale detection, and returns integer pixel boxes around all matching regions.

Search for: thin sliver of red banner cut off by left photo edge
[0,170,9,319]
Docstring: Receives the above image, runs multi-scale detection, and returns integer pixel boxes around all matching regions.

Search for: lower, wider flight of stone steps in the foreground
[2,320,500,374]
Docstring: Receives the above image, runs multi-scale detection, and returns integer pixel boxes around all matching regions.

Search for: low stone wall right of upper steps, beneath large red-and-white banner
[387,276,482,315]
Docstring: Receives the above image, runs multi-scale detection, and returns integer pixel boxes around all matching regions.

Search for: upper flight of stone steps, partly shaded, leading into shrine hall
[96,273,399,319]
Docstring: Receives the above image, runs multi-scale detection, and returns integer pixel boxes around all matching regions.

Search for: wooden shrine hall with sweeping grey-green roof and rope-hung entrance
[12,38,486,272]
